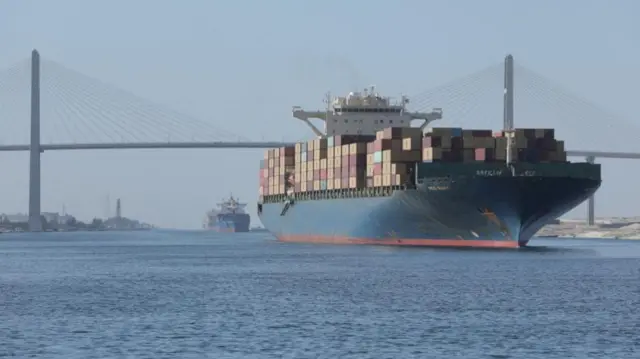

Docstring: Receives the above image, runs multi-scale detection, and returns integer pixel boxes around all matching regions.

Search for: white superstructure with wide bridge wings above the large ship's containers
[293,86,442,137]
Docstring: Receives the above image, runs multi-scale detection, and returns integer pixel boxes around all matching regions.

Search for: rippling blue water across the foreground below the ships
[0,232,640,359]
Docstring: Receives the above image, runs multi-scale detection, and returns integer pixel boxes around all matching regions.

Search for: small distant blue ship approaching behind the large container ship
[203,195,251,232]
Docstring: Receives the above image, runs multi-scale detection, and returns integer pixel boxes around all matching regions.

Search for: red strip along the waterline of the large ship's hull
[276,235,520,248]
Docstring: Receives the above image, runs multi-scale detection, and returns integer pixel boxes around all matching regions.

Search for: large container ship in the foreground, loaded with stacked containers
[257,88,601,248]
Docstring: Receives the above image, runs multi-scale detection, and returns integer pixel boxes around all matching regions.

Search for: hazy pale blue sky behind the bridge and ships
[0,0,640,228]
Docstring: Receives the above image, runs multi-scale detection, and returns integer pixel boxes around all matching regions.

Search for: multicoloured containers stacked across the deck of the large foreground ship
[260,127,567,196]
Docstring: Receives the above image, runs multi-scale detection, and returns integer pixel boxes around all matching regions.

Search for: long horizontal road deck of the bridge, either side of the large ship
[0,141,640,160]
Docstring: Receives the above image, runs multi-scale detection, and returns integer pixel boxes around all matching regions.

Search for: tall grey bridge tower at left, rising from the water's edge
[29,50,42,232]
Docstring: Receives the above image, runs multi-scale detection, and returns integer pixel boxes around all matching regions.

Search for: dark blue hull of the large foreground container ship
[260,167,600,248]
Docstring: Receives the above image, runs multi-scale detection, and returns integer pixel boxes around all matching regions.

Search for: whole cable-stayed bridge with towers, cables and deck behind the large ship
[0,50,640,231]
